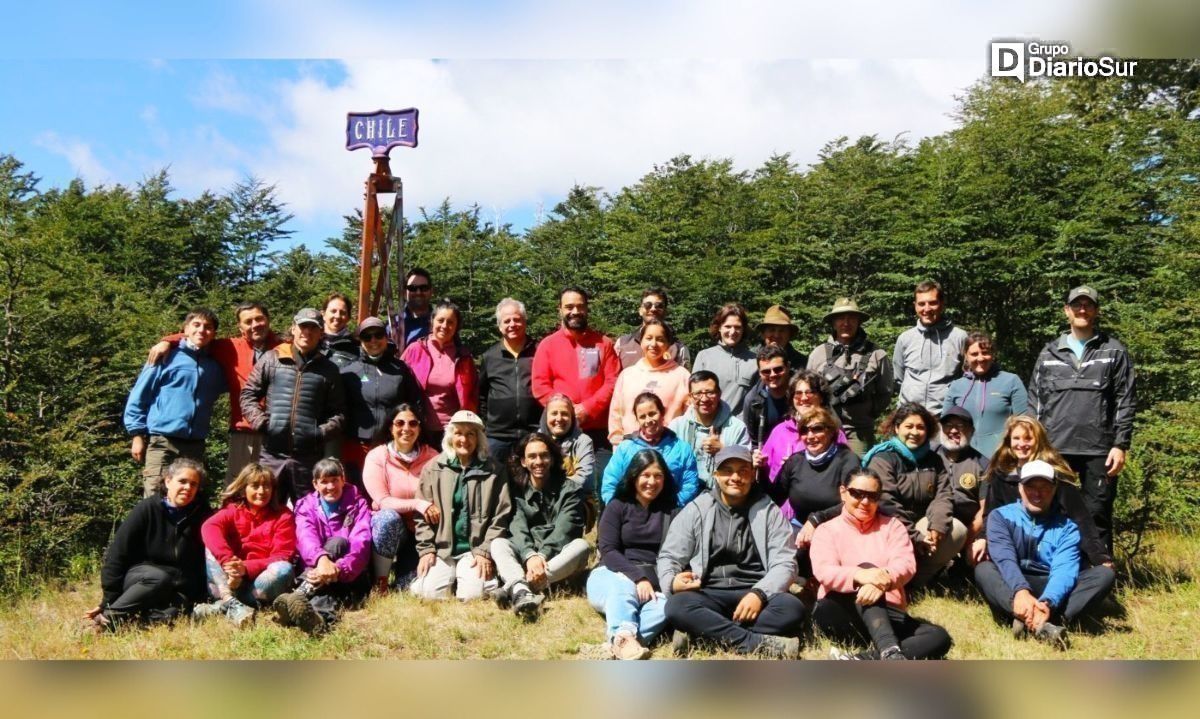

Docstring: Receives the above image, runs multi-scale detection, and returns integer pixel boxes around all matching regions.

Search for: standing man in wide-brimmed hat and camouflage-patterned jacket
[809,298,894,456]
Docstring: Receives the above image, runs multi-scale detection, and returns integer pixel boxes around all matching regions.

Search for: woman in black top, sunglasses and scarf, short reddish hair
[767,407,860,577]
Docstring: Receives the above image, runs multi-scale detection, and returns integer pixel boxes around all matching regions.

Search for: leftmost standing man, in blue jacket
[125,307,227,497]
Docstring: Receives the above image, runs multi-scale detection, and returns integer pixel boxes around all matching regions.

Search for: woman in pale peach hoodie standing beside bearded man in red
[608,317,690,447]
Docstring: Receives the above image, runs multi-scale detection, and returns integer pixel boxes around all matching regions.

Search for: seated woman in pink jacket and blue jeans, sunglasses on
[362,403,439,592]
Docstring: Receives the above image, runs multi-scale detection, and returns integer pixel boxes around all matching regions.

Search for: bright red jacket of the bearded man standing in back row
[533,328,620,430]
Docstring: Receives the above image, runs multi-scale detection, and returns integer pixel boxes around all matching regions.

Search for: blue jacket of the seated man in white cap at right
[988,501,1079,607]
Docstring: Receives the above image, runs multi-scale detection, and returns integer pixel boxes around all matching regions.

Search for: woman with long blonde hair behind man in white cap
[968,414,1112,569]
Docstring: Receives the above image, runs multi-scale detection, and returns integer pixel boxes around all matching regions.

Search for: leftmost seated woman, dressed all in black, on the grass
[84,457,212,631]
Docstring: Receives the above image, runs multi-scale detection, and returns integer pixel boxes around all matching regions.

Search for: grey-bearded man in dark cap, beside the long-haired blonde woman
[937,407,988,564]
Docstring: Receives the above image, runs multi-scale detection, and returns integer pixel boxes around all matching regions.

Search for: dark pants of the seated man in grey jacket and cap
[666,589,808,654]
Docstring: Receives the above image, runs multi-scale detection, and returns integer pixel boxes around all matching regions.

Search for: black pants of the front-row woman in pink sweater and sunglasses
[812,593,953,659]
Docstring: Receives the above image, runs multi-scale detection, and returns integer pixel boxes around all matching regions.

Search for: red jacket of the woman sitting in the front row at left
[200,502,296,580]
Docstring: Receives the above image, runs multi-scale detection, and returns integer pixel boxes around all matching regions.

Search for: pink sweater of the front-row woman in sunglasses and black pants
[809,509,917,610]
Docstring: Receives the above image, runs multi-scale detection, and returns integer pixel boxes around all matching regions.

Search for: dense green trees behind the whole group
[0,61,1200,587]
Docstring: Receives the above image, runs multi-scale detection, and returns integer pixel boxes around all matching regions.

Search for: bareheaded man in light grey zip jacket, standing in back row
[892,280,967,414]
